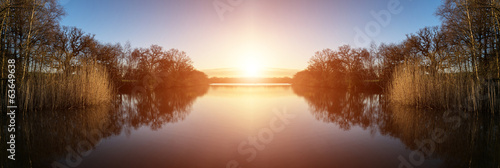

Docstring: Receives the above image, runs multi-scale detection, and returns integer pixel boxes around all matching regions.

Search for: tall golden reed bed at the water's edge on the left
[19,63,113,110]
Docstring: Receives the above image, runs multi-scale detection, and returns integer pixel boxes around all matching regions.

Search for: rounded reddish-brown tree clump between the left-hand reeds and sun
[118,45,208,89]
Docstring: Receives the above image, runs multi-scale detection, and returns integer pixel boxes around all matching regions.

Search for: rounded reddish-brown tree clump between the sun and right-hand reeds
[293,45,380,88]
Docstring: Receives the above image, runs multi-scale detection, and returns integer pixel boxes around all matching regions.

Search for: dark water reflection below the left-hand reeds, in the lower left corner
[1,106,114,167]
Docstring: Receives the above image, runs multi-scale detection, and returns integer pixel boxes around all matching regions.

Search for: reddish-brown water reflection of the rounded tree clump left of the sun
[115,86,208,130]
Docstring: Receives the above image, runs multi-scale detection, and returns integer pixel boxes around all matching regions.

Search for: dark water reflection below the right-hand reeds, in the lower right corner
[388,105,500,167]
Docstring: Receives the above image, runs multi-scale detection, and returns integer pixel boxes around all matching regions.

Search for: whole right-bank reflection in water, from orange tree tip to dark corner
[293,86,500,167]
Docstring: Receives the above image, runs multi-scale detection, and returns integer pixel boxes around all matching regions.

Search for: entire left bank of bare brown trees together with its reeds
[0,0,208,109]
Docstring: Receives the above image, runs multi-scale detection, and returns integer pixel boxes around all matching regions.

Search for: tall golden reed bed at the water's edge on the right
[388,63,500,114]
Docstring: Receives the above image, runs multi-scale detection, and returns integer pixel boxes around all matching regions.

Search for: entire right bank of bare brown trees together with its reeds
[293,0,500,112]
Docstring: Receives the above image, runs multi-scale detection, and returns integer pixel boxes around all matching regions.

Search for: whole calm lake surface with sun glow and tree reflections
[1,85,500,168]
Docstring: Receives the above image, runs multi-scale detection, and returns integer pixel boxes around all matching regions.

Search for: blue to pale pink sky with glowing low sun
[59,0,442,77]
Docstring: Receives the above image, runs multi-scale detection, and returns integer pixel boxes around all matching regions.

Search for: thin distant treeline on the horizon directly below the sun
[209,77,292,83]
